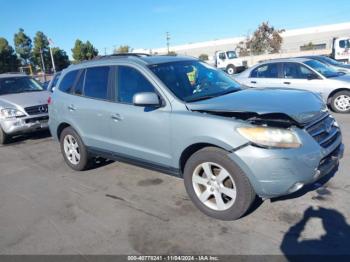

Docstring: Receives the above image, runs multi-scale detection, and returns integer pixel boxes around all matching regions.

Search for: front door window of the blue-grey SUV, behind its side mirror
[116,66,154,104]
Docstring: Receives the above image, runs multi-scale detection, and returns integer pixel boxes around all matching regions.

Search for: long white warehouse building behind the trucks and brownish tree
[134,22,350,60]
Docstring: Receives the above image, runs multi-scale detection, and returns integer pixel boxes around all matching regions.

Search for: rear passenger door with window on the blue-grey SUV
[60,66,111,148]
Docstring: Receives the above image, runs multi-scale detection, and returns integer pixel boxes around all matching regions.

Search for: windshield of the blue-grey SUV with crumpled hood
[150,61,240,102]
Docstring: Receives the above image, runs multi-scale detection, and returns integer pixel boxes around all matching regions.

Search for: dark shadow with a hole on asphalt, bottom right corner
[280,207,350,261]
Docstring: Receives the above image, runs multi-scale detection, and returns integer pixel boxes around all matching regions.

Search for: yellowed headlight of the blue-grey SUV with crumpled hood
[237,127,302,148]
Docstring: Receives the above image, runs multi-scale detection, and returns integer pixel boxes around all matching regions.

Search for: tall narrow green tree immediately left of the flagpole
[32,31,52,73]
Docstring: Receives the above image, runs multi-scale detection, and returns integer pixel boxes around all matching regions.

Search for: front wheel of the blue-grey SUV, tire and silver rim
[184,147,256,220]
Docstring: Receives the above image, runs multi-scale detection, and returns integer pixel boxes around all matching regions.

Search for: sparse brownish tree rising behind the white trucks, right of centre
[237,22,284,56]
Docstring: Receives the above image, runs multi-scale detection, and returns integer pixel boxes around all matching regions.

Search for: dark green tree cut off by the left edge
[0,37,19,73]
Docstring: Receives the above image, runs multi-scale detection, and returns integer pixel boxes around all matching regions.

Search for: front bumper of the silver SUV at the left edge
[1,114,49,135]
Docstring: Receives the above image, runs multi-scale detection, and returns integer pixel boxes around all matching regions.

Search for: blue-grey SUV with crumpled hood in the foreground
[49,54,344,220]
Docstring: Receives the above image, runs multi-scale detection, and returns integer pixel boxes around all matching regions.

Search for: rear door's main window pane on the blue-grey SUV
[84,66,110,100]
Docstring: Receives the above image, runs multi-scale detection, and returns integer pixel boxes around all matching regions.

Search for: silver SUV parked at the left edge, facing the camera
[0,74,49,144]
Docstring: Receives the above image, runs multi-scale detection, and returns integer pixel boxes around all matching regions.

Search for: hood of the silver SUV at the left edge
[0,91,50,108]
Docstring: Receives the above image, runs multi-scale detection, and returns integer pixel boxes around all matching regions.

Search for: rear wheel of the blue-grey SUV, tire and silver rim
[60,127,90,171]
